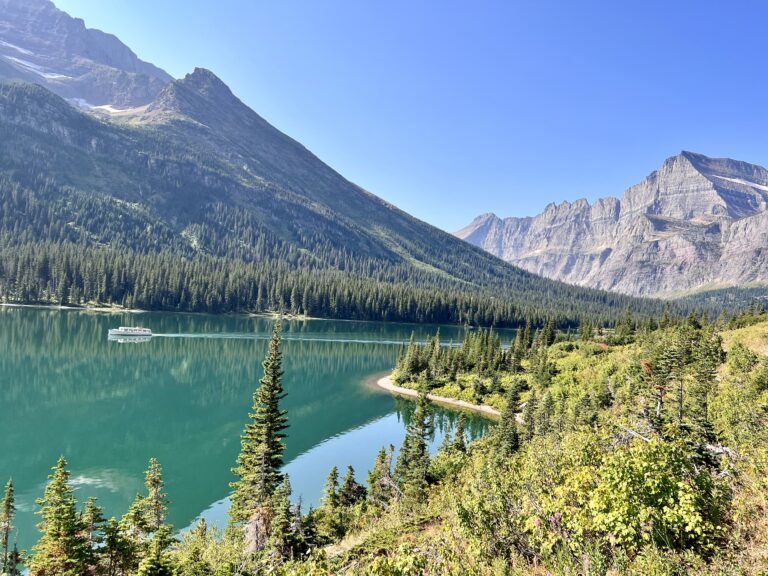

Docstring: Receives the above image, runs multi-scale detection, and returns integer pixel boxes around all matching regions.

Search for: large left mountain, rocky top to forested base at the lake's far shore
[0,0,663,324]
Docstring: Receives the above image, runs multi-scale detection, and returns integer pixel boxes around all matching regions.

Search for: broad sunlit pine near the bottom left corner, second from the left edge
[29,456,90,576]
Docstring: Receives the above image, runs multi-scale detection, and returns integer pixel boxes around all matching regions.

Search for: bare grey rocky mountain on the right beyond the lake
[455,152,768,296]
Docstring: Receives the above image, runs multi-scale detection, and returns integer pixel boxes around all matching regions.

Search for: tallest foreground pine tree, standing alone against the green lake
[229,322,288,522]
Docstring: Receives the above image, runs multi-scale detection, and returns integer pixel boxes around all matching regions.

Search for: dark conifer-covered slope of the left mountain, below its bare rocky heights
[0,79,686,327]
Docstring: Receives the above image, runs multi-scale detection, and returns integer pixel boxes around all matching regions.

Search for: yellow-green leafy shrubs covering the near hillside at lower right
[284,323,768,576]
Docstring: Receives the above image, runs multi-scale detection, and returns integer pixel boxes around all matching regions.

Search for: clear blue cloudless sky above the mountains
[54,0,768,231]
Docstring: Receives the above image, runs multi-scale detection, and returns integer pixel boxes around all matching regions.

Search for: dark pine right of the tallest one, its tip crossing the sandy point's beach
[394,389,433,501]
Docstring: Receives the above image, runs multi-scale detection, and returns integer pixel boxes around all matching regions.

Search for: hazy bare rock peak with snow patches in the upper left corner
[0,0,172,108]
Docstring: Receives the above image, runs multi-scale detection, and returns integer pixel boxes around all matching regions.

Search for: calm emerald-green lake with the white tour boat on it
[0,307,498,548]
